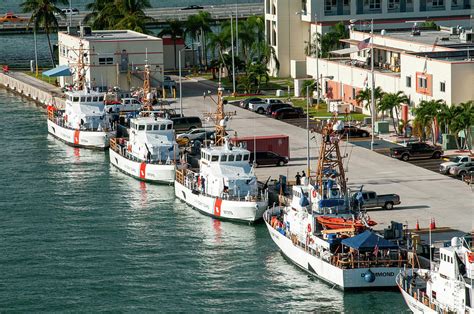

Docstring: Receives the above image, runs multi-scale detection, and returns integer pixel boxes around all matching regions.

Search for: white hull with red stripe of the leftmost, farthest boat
[48,119,114,149]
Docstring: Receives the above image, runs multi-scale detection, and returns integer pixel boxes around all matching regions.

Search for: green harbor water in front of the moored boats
[0,89,407,313]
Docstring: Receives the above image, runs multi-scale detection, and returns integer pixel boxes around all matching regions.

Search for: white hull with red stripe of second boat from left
[109,148,175,184]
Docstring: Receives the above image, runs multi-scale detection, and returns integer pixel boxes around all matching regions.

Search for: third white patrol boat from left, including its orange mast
[175,83,268,222]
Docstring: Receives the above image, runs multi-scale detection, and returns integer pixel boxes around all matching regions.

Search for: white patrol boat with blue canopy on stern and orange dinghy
[263,118,415,290]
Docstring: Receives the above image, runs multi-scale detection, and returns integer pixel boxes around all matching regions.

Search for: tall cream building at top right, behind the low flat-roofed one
[265,0,472,77]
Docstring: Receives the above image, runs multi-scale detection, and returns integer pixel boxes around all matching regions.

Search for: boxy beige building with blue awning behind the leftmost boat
[58,27,164,90]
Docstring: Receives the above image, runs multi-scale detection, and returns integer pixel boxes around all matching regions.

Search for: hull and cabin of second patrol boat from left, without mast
[109,116,177,184]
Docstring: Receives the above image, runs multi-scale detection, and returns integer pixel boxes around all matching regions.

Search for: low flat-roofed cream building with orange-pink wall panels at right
[306,28,474,113]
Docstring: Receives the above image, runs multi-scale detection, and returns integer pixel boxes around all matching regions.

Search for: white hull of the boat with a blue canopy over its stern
[265,221,401,290]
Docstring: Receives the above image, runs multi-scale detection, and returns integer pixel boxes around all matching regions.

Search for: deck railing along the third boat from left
[176,168,268,202]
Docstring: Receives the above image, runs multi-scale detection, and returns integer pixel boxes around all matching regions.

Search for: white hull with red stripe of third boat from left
[174,181,268,222]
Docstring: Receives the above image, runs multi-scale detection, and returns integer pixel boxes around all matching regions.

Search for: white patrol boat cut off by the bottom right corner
[397,237,474,313]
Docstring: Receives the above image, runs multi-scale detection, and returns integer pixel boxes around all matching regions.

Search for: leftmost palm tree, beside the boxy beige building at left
[21,0,68,67]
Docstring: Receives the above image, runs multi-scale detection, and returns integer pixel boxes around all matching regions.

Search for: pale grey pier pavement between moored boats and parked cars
[174,80,474,232]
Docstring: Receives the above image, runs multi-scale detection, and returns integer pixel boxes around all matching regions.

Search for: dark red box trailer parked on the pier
[231,135,290,159]
